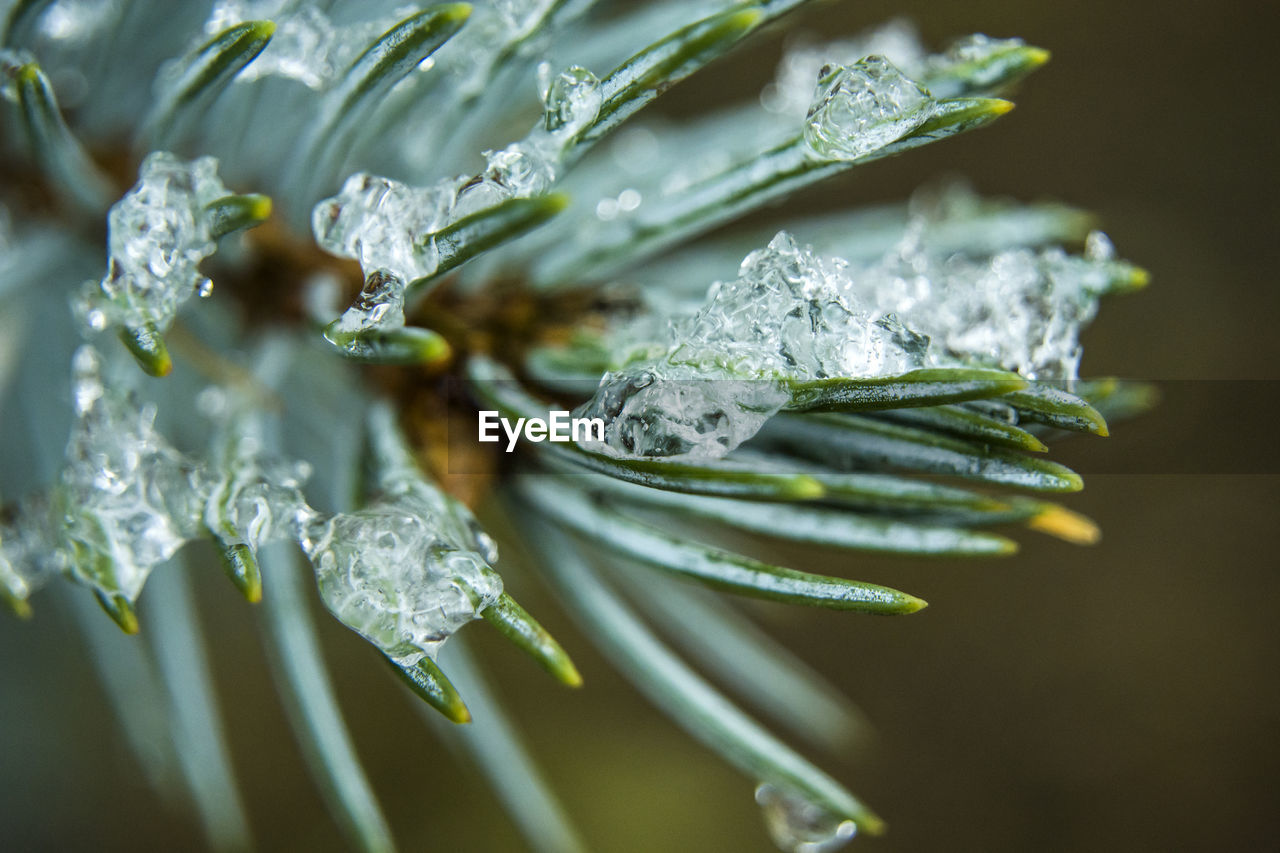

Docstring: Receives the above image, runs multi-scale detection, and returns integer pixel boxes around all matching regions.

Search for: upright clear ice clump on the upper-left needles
[74,151,229,332]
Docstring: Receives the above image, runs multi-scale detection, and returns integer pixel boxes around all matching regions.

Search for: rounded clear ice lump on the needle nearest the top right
[804,56,934,160]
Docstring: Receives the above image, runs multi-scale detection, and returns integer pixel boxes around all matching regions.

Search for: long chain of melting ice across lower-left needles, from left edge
[0,346,502,650]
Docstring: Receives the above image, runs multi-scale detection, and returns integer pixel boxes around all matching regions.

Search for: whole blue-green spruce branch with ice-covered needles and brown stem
[0,0,1153,853]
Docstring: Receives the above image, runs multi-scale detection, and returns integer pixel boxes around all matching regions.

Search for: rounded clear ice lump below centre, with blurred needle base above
[302,407,502,667]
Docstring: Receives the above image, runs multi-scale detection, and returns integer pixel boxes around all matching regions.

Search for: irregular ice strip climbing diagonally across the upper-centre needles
[311,65,602,346]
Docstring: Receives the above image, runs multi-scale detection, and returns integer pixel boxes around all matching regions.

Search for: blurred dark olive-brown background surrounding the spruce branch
[0,0,1280,853]
